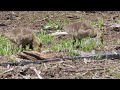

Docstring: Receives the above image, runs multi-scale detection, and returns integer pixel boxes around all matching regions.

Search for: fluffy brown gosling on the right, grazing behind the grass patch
[63,22,103,43]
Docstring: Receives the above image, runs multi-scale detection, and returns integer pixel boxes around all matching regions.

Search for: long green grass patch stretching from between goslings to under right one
[37,32,101,55]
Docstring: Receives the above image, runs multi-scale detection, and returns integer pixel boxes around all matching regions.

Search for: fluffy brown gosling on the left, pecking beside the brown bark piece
[3,27,42,51]
